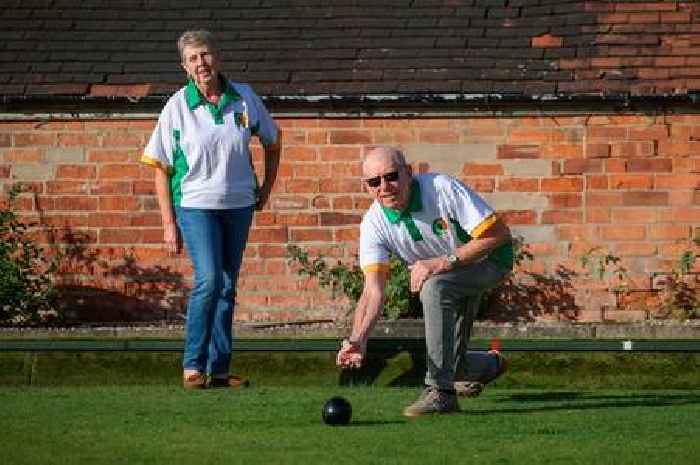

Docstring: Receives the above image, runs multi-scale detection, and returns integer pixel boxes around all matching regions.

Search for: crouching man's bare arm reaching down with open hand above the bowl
[336,272,387,367]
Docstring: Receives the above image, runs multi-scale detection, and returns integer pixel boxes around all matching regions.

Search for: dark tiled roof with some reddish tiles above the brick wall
[0,0,700,101]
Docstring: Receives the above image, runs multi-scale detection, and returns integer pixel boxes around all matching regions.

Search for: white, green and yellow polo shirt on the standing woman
[141,78,278,209]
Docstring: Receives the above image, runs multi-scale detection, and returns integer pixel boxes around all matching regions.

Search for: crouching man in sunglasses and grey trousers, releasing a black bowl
[337,147,513,417]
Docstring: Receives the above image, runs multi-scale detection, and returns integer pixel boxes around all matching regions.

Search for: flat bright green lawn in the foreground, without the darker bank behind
[0,385,700,465]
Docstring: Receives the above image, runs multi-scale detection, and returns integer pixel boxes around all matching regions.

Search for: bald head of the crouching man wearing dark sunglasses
[362,152,411,210]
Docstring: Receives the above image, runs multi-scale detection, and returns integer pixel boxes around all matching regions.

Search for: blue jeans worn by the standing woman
[175,206,253,376]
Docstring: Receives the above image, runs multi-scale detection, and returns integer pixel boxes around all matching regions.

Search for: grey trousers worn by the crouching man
[420,260,510,389]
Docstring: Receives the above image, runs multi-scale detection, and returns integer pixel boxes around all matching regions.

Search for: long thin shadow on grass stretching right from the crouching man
[463,391,700,415]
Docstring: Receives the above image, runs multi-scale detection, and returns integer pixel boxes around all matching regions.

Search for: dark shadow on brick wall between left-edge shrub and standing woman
[52,230,187,323]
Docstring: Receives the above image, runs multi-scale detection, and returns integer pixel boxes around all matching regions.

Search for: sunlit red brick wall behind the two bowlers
[0,115,700,320]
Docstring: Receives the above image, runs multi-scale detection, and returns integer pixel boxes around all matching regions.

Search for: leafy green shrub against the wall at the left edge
[0,186,58,325]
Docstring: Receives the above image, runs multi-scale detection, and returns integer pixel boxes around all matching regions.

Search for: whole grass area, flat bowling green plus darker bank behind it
[0,340,700,465]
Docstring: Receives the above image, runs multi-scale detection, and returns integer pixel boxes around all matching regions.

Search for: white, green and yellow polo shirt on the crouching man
[360,173,513,272]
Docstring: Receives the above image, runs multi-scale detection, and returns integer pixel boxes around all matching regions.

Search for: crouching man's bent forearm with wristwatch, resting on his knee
[411,218,510,292]
